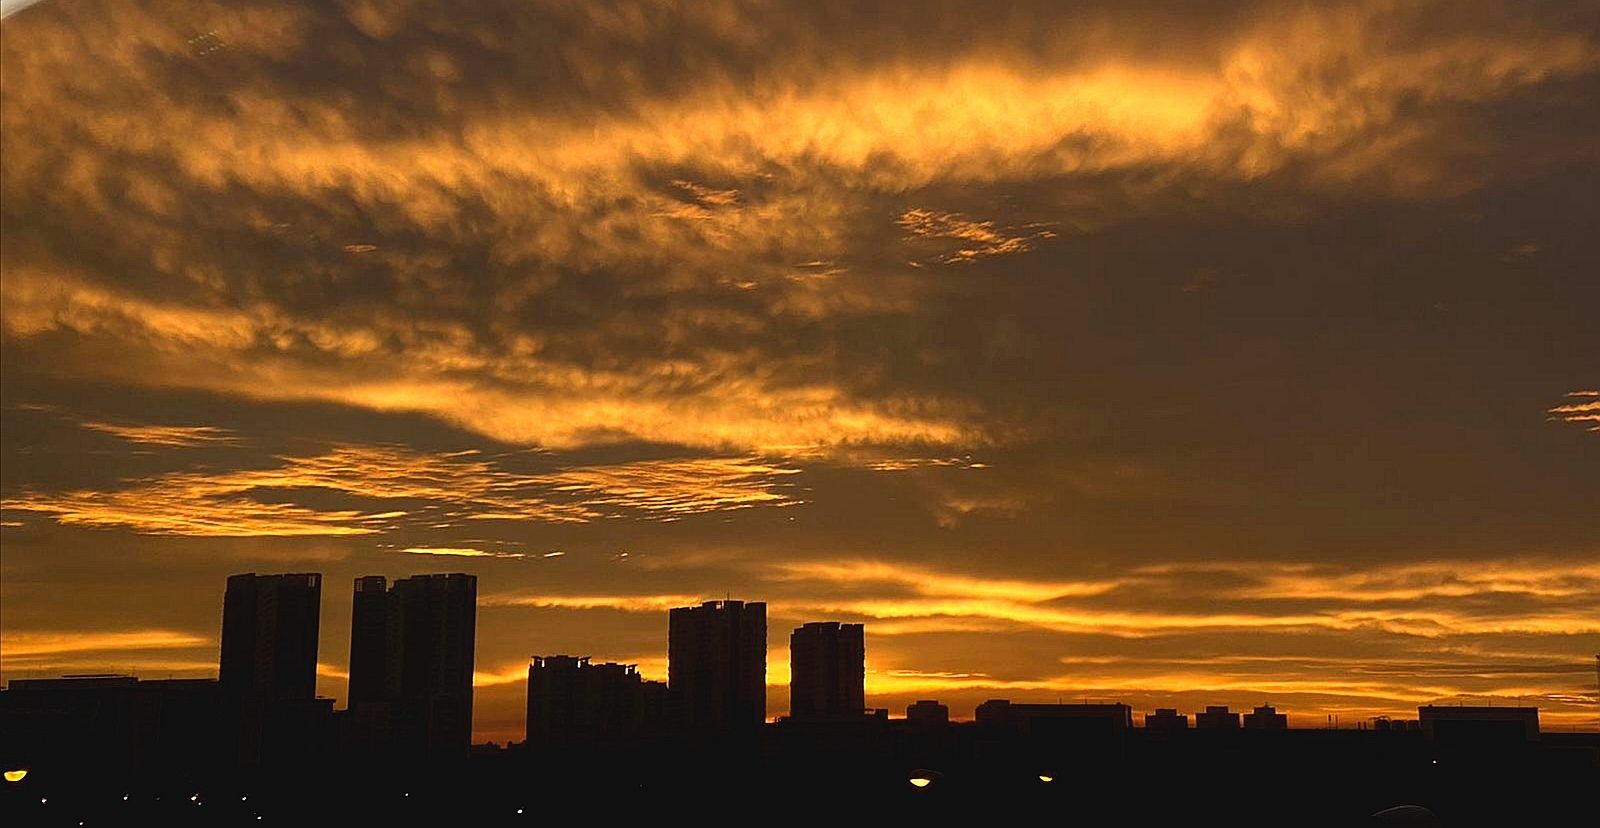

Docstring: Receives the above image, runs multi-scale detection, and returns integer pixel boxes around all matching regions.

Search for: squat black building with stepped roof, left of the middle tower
[526,655,667,746]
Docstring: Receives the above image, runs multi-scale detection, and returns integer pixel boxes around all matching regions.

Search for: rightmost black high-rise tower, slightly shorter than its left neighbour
[789,622,867,719]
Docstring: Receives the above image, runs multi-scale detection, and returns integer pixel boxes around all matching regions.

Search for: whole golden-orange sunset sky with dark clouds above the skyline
[0,0,1600,742]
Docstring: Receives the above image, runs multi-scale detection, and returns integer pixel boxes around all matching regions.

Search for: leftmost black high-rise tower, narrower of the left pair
[221,572,322,702]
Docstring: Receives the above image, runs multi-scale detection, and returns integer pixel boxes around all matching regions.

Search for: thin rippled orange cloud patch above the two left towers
[0,444,800,537]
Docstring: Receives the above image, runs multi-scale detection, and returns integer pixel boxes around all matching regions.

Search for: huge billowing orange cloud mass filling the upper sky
[3,2,1600,460]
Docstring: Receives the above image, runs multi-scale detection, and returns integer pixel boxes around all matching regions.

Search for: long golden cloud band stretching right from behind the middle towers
[483,559,1600,638]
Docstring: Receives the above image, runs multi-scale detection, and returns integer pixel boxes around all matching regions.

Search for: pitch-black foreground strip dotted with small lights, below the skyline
[0,726,1600,826]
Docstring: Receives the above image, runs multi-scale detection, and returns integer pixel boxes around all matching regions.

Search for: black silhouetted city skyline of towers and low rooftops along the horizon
[9,572,1600,748]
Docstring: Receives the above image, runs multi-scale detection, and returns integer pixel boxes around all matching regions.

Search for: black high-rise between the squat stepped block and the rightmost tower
[667,601,766,735]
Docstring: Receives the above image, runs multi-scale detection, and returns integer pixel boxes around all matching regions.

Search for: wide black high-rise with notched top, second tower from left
[350,572,478,756]
